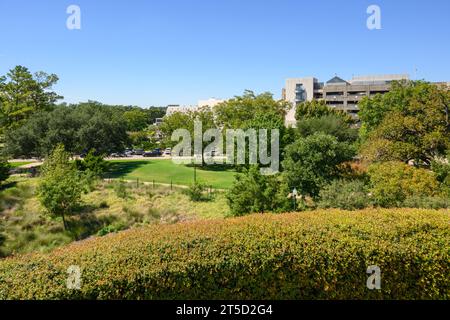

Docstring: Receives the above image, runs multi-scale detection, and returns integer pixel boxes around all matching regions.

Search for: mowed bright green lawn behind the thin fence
[108,159,235,189]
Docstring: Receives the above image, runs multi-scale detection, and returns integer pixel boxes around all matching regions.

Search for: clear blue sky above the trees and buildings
[0,0,450,107]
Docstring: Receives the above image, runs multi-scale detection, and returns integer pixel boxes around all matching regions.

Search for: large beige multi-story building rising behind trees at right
[282,74,409,126]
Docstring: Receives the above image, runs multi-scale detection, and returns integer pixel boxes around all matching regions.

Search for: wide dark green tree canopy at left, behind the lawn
[5,102,129,157]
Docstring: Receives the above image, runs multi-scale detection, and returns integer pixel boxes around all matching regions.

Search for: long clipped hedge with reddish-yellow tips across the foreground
[0,209,450,299]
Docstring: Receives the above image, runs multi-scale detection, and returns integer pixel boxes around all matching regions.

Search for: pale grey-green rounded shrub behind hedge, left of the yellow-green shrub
[318,180,371,210]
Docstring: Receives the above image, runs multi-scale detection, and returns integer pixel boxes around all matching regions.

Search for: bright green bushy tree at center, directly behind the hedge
[227,166,292,216]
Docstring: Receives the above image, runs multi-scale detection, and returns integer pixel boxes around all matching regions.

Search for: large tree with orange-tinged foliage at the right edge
[360,81,450,166]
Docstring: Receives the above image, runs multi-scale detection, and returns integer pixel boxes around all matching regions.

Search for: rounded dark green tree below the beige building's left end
[282,132,355,197]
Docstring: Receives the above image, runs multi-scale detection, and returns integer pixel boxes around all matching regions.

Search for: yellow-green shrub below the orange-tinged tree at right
[368,162,440,207]
